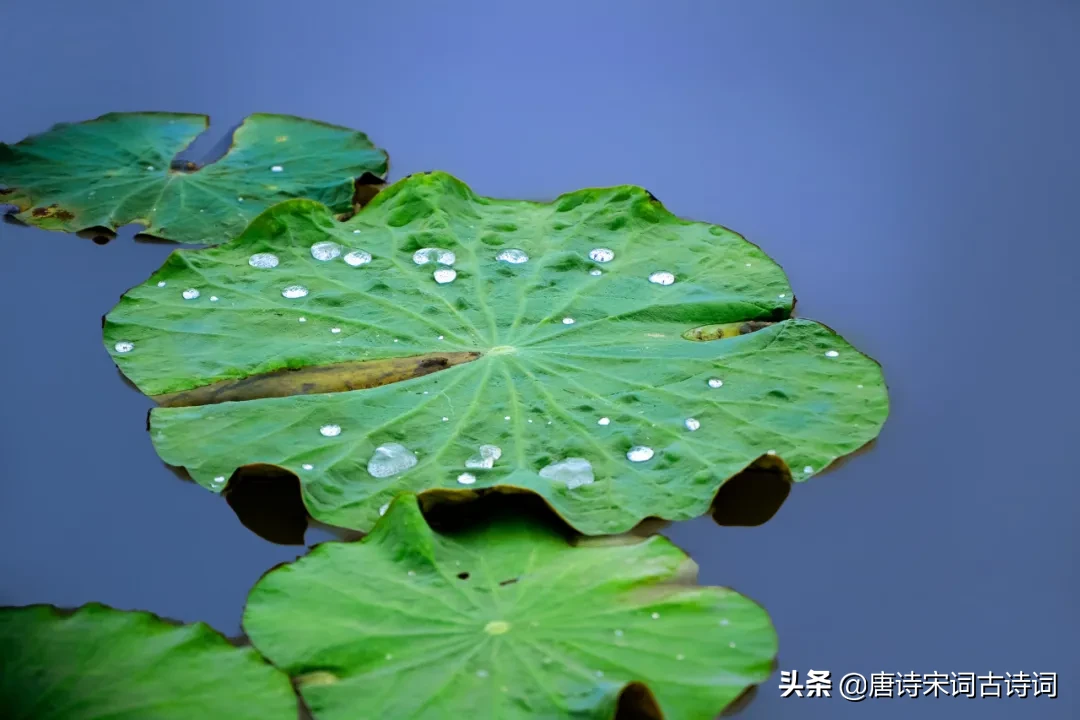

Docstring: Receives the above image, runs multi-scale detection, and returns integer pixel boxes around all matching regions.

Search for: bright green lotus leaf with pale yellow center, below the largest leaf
[244,495,777,720]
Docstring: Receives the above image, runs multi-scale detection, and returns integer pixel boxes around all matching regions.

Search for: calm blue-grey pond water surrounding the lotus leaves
[0,0,1080,720]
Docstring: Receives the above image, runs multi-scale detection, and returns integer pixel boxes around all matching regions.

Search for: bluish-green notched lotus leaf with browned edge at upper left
[0,112,387,239]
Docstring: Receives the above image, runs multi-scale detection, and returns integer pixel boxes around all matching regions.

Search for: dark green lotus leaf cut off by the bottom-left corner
[0,604,297,720]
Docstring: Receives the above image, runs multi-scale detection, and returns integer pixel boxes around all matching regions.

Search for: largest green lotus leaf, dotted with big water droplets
[105,174,888,534]
